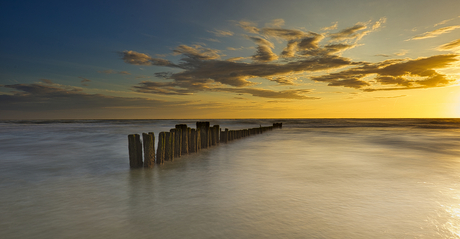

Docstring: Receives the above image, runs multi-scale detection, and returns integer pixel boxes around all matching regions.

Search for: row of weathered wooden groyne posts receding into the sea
[128,122,283,168]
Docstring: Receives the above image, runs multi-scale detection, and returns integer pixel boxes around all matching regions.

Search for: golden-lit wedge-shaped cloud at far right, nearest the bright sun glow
[311,54,458,91]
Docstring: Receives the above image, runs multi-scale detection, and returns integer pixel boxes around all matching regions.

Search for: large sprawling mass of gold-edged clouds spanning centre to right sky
[122,18,458,99]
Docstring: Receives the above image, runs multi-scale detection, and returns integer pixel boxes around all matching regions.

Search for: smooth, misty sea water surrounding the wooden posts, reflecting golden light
[0,119,460,239]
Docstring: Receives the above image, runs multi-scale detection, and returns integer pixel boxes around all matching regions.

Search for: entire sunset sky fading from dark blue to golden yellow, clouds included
[0,0,460,119]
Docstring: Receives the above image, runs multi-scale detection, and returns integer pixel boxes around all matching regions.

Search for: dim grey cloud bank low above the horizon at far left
[0,84,170,111]
